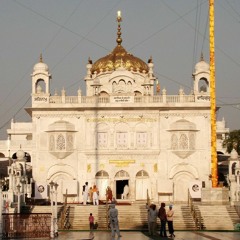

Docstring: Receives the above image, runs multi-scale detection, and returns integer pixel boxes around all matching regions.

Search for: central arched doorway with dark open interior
[114,170,130,199]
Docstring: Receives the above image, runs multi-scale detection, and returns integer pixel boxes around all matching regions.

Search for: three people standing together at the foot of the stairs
[147,203,175,237]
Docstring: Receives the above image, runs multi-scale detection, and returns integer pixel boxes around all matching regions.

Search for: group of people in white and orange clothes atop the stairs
[82,182,99,205]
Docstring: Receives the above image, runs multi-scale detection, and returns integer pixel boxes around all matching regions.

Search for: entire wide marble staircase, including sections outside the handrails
[21,201,240,230]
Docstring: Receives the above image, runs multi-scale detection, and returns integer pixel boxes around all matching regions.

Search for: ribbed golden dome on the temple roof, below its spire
[91,44,148,73]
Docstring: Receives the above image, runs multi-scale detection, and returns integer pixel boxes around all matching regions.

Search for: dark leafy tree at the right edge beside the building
[223,130,240,155]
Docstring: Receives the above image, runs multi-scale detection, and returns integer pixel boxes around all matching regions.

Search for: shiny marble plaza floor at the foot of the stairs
[16,231,240,240]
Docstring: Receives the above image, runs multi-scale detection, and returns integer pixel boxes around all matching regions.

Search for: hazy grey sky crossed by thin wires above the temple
[0,0,240,139]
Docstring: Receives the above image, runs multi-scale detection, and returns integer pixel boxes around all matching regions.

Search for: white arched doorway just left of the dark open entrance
[95,170,109,200]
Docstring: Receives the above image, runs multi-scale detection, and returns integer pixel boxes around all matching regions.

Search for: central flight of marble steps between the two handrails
[63,202,195,230]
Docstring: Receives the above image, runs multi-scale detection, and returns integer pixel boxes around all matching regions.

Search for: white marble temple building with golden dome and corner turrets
[0,15,229,202]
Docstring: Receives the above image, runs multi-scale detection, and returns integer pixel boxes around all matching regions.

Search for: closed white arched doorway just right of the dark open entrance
[136,170,151,200]
